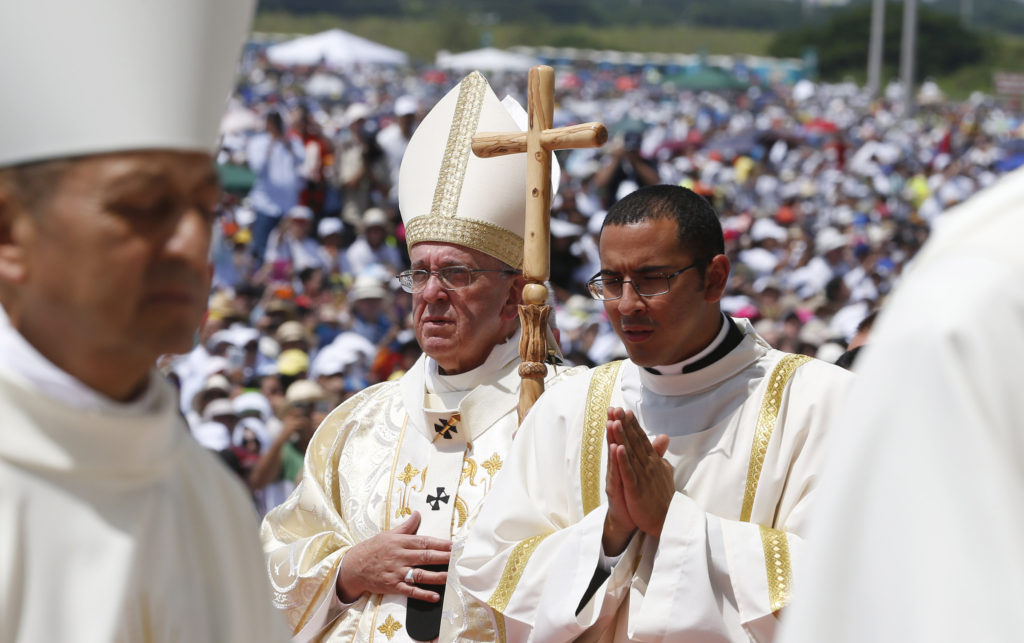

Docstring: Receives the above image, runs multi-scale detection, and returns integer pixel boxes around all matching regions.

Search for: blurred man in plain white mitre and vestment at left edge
[0,0,287,643]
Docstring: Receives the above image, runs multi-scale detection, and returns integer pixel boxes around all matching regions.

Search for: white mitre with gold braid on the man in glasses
[398,72,557,268]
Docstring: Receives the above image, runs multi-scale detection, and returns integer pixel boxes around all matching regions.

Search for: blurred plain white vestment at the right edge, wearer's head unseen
[780,166,1024,643]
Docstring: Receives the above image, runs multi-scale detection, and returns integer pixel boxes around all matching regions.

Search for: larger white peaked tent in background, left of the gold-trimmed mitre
[266,29,409,69]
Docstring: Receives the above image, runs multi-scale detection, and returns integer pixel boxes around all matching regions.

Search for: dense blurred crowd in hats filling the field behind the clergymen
[169,51,1022,511]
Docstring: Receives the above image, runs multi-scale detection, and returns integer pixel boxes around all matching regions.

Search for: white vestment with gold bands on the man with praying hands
[458,320,852,643]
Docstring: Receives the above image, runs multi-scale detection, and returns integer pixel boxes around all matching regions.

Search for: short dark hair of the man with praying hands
[601,185,725,277]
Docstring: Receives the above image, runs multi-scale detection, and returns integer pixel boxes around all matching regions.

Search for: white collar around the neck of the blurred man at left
[0,306,160,413]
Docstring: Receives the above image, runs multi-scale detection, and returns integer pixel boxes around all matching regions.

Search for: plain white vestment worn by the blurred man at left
[0,362,288,643]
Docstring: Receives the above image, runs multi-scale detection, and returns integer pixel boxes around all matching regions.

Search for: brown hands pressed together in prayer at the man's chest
[601,408,676,556]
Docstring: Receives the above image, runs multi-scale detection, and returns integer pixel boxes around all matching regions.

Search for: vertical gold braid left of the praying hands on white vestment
[580,359,623,515]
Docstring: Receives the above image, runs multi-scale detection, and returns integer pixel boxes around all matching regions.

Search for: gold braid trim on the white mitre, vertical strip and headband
[406,72,522,268]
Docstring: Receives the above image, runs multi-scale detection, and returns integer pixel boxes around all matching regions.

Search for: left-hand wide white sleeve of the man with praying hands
[458,387,642,642]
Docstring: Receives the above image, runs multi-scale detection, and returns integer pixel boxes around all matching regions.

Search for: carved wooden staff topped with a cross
[473,65,608,423]
